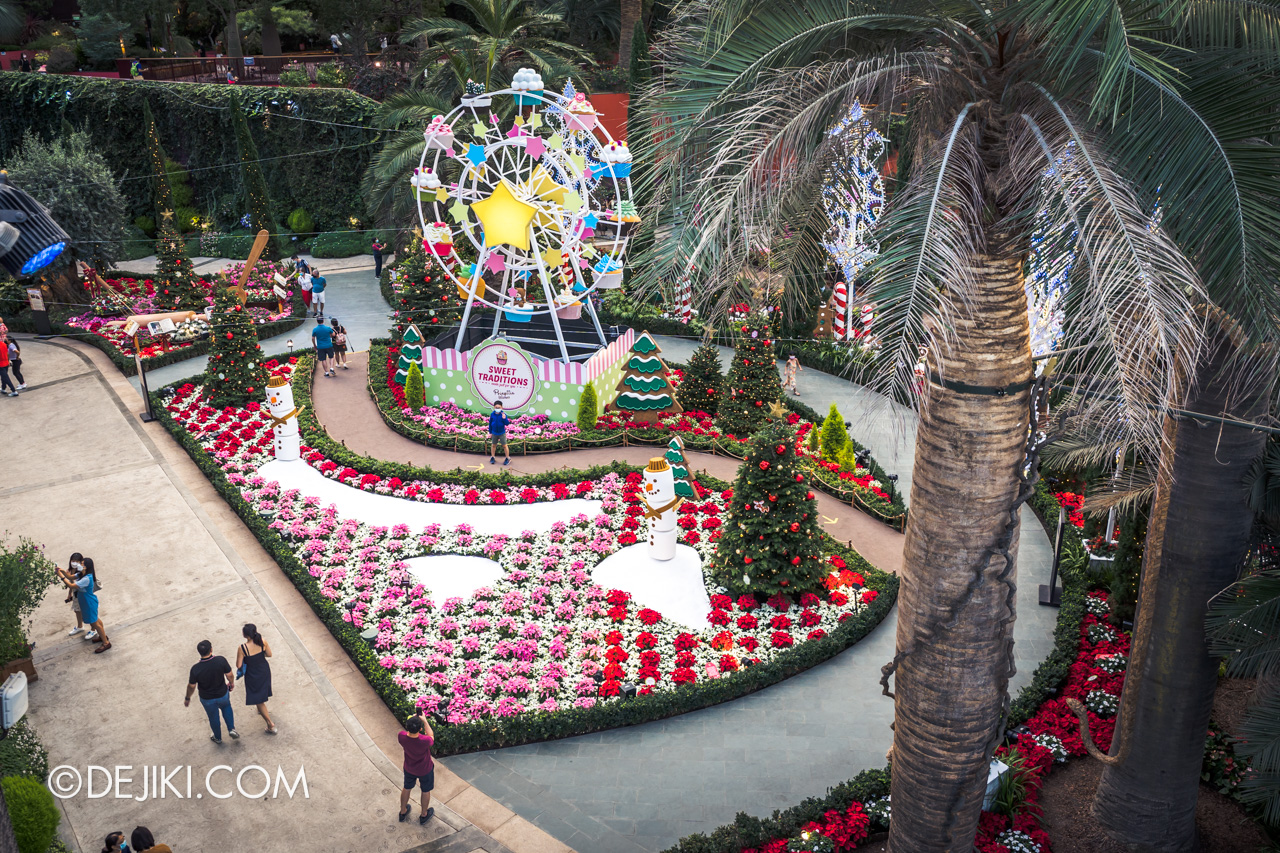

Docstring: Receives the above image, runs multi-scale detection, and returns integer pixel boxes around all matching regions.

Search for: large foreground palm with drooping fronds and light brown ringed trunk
[637,0,1280,853]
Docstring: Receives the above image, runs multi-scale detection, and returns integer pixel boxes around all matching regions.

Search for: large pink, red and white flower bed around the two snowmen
[161,359,892,725]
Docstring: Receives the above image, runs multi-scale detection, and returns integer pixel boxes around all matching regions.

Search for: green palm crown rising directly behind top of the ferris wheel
[403,0,591,93]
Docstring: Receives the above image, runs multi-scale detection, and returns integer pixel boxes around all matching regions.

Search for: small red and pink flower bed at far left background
[63,272,293,364]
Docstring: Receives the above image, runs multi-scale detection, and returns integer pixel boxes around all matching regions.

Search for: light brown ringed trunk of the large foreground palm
[888,256,1033,853]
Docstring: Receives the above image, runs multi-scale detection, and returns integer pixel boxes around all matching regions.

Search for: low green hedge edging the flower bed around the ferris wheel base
[369,338,908,533]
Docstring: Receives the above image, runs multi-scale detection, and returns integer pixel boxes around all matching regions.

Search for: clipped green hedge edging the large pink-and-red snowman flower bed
[152,355,899,756]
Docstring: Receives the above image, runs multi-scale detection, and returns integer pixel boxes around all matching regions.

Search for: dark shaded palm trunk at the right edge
[1093,316,1266,853]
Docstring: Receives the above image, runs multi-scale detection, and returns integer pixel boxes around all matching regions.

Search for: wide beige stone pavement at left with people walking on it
[0,338,571,853]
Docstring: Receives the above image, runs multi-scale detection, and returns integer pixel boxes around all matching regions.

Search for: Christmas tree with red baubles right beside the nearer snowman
[714,420,827,596]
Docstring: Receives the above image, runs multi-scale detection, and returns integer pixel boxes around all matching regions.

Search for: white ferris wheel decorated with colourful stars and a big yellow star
[412,75,639,362]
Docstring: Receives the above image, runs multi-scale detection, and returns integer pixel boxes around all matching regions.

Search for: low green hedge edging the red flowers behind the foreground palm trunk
[663,482,1088,853]
